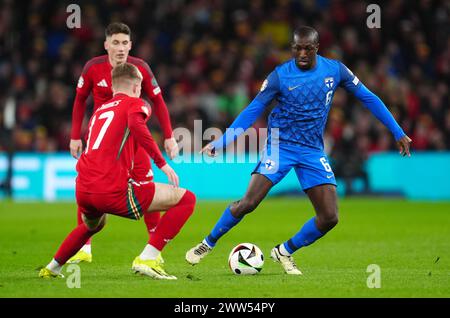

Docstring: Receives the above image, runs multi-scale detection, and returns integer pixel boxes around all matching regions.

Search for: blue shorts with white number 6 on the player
[252,143,336,191]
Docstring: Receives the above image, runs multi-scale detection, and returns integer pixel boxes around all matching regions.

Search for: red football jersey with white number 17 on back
[76,94,165,193]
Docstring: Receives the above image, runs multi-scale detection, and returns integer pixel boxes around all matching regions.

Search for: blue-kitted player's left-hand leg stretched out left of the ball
[186,174,273,265]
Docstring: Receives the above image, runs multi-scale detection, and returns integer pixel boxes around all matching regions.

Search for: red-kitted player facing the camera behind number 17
[69,23,178,263]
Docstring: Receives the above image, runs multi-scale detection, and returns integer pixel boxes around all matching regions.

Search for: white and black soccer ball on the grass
[228,243,264,275]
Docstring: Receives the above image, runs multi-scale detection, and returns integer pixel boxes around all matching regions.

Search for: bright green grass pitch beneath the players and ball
[0,198,450,298]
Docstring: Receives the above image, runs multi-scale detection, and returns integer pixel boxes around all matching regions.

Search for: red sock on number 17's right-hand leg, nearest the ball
[147,190,195,251]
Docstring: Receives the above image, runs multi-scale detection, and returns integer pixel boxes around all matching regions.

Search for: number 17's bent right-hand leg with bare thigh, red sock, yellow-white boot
[132,183,195,280]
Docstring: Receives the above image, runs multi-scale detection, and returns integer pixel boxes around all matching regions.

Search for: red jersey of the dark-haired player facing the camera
[71,55,172,139]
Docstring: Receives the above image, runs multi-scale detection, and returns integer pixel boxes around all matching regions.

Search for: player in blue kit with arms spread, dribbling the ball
[186,26,411,275]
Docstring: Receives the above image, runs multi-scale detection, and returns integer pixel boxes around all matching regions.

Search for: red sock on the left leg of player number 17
[54,223,103,265]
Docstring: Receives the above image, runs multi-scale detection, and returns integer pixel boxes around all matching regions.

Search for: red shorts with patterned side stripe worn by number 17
[76,182,155,220]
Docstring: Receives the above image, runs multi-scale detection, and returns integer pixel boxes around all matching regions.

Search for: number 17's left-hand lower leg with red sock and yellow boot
[39,215,106,278]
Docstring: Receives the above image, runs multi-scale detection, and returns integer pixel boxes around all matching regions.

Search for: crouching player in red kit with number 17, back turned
[39,63,195,279]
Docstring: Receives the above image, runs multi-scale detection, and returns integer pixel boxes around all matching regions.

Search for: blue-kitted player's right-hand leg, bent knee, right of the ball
[270,184,338,275]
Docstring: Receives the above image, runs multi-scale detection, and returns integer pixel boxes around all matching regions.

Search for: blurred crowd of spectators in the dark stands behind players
[0,0,450,169]
